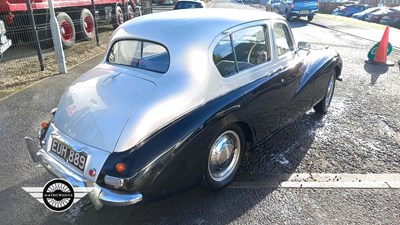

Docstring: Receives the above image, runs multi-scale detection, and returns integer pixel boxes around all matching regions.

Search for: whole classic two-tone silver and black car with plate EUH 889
[26,9,342,207]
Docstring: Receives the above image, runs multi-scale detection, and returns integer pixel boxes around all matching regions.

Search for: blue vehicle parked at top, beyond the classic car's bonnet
[266,0,319,21]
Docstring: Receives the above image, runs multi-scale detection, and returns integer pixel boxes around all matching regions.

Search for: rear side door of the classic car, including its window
[225,24,281,142]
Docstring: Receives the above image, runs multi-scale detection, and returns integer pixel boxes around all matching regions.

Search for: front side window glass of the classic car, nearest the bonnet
[273,23,294,56]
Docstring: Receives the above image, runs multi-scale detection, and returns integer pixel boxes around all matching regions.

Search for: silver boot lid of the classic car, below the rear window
[54,68,156,152]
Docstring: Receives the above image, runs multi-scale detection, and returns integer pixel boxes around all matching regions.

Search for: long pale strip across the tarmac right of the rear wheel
[228,173,400,189]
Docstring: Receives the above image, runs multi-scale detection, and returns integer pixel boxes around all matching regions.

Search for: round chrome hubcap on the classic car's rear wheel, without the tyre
[208,131,241,181]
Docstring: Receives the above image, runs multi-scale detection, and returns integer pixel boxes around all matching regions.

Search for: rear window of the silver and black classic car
[107,40,170,73]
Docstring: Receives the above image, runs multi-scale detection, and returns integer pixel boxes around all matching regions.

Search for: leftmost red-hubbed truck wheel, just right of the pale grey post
[57,12,76,48]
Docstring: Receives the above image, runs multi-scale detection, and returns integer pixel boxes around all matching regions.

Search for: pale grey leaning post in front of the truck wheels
[48,0,67,74]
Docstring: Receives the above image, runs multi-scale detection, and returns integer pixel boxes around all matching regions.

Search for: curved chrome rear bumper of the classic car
[25,137,142,209]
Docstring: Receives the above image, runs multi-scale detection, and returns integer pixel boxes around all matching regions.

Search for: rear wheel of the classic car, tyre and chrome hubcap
[203,125,245,191]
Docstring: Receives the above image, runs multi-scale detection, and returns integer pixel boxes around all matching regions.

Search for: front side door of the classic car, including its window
[272,20,313,126]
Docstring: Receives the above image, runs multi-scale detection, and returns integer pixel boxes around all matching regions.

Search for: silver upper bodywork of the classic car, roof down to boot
[54,9,282,152]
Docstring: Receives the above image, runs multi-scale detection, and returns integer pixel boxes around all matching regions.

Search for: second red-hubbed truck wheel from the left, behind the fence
[76,9,96,40]
